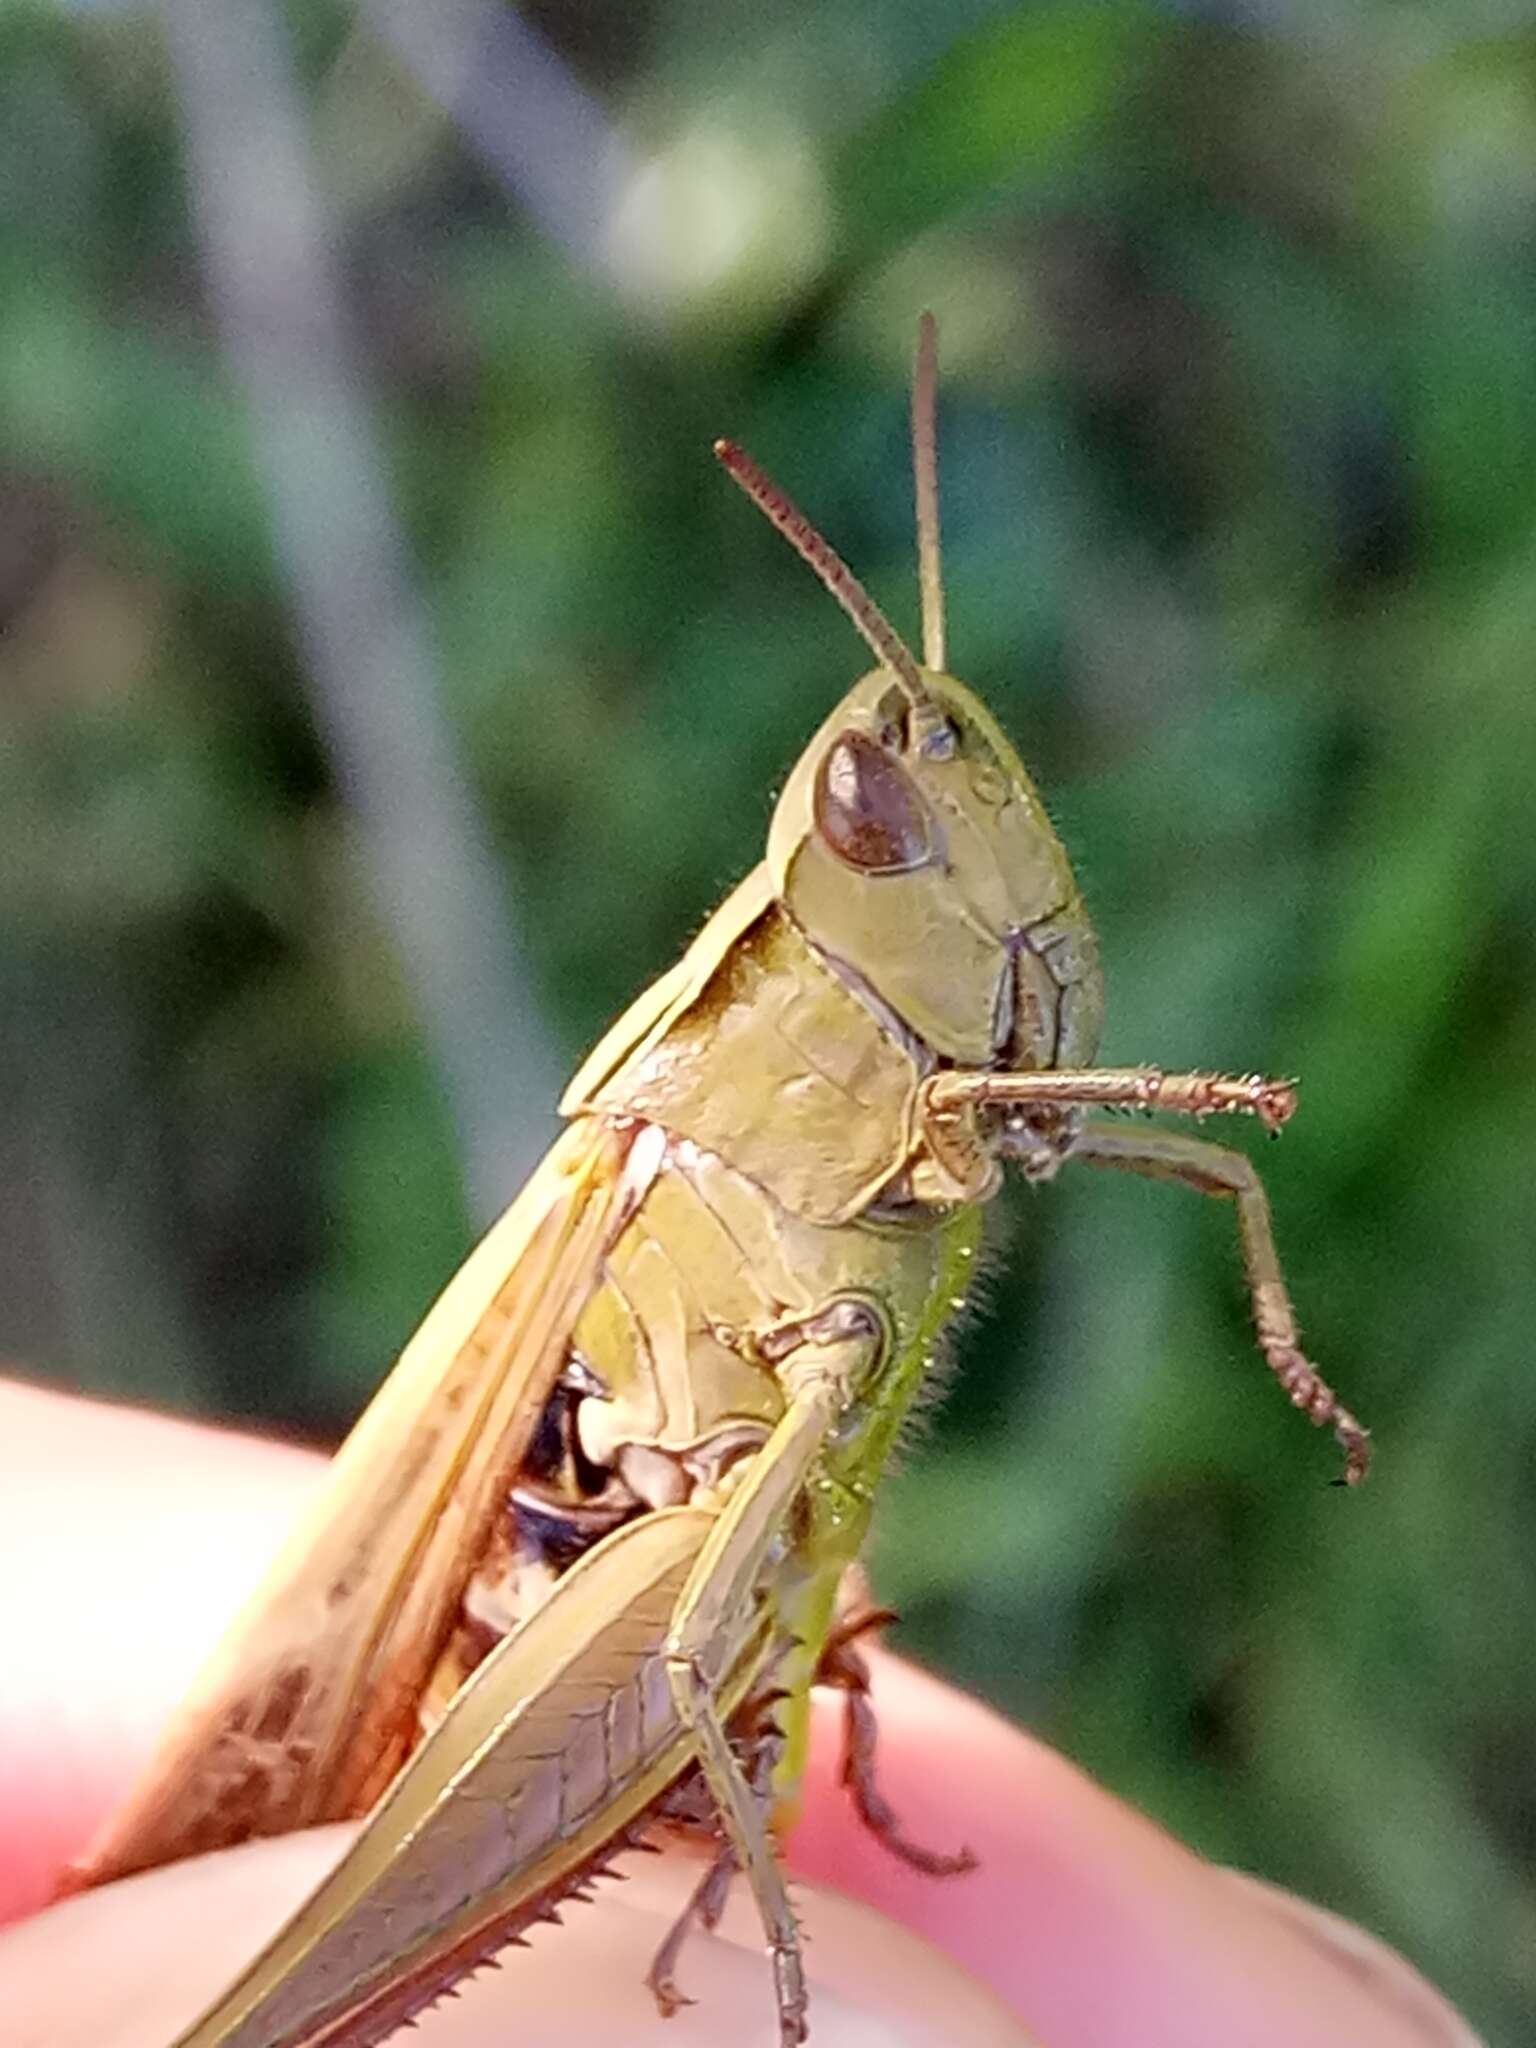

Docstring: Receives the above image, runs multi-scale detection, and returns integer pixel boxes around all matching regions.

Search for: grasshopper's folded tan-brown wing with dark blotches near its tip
[74,1118,653,1886]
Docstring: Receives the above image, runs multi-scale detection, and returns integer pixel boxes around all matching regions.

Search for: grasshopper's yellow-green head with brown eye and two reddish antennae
[715,315,1104,1067]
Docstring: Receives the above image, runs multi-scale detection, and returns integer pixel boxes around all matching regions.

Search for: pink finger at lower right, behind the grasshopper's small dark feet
[791,1653,1470,2048]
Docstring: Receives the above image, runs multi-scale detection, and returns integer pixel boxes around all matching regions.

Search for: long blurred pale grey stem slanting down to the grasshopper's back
[162,0,559,1219]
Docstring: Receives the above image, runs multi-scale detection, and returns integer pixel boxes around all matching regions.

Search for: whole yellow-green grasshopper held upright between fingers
[66,317,1368,2048]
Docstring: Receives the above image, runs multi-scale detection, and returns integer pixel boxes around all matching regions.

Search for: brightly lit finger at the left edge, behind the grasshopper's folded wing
[0,1382,324,1921]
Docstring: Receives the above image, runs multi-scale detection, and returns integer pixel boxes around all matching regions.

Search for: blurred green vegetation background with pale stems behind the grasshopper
[0,0,1536,2042]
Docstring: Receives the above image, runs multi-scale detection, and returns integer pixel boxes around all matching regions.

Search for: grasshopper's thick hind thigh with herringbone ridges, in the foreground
[176,1507,766,2048]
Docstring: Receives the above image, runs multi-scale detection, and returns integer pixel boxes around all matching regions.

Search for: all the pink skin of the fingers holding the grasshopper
[0,1382,1475,2048]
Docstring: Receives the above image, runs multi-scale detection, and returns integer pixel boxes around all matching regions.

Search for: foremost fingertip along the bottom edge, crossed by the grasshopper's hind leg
[0,1829,1034,2048]
